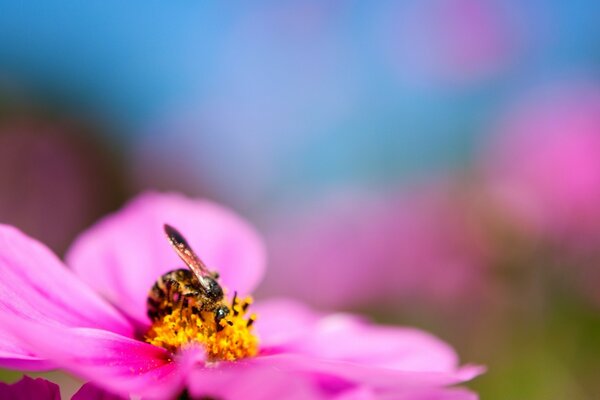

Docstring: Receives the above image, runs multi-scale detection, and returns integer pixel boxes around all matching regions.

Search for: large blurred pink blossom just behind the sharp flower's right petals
[263,181,487,307]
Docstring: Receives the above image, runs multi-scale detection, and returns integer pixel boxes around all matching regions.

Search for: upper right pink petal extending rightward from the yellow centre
[254,300,458,371]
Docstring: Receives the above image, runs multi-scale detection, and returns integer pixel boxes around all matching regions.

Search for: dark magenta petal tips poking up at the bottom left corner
[0,375,123,400]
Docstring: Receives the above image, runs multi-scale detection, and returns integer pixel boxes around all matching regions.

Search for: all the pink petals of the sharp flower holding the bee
[0,194,482,399]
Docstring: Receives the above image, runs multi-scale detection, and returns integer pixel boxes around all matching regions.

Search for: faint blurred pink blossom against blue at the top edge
[381,0,524,84]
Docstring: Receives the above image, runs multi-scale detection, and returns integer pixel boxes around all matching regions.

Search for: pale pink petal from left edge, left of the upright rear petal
[0,225,132,369]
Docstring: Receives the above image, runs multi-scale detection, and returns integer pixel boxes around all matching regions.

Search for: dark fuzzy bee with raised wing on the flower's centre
[147,224,229,331]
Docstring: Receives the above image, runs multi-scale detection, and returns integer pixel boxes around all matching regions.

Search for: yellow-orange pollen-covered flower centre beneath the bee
[145,296,258,361]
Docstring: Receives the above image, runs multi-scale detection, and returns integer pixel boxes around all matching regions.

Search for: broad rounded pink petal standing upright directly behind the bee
[67,193,264,323]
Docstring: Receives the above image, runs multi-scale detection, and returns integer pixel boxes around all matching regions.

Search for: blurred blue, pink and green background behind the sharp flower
[0,0,600,400]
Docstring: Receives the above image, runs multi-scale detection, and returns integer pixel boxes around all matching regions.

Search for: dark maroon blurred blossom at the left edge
[0,118,122,254]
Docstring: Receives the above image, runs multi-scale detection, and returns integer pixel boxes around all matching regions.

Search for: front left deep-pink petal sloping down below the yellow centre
[0,313,198,398]
